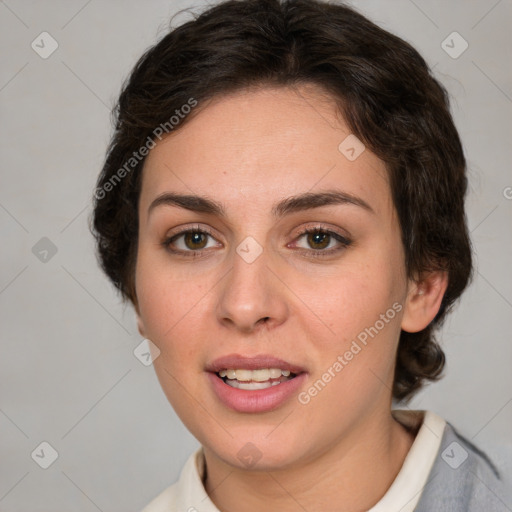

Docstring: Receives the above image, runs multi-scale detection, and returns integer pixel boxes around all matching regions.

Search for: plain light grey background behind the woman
[0,0,512,511]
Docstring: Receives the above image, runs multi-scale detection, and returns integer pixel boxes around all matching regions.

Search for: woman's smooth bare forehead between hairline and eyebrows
[141,86,390,217]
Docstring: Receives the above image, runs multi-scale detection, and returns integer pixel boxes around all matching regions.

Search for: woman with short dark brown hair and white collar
[94,0,506,512]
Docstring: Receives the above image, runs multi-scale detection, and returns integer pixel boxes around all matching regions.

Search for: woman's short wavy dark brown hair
[92,0,472,400]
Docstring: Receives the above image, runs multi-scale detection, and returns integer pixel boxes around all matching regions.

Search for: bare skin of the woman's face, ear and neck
[135,86,447,512]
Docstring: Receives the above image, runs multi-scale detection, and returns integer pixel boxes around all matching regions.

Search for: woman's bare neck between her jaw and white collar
[204,411,415,512]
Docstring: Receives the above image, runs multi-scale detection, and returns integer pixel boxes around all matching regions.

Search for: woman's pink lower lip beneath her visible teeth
[208,372,307,412]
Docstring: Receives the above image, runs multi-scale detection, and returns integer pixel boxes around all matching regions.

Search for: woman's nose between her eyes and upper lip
[217,242,288,333]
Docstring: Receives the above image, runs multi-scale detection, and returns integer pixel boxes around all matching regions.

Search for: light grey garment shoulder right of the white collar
[415,422,512,512]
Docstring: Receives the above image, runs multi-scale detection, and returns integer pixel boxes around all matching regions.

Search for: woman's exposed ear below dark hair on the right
[401,270,448,332]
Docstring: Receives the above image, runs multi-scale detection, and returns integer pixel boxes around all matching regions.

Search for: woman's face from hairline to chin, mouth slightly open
[135,87,408,468]
